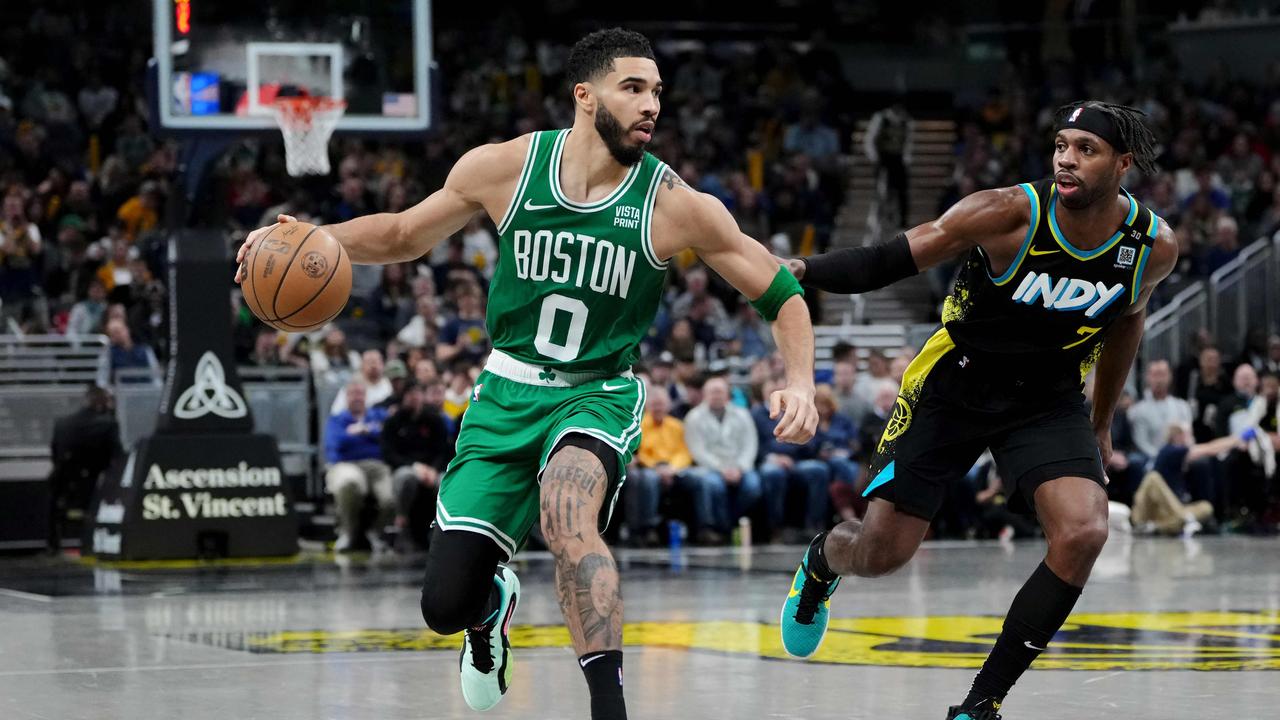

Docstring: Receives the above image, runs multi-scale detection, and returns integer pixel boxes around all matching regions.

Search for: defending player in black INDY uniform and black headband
[782,101,1178,720]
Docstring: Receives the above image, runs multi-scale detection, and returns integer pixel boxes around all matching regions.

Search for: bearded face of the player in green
[590,58,662,165]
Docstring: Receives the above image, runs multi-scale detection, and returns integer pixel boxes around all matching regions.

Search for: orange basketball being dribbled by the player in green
[241,223,351,333]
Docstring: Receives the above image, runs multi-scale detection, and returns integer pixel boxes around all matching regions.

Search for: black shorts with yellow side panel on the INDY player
[863,329,1106,520]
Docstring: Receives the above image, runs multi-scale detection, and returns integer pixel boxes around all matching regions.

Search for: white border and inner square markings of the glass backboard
[151,0,431,132]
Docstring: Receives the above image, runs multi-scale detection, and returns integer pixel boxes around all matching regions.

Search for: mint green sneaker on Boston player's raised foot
[458,565,520,710]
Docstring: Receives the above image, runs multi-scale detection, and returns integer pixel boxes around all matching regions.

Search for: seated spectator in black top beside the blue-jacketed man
[381,381,453,551]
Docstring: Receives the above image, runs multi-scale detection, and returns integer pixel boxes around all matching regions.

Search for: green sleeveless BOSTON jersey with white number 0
[488,129,667,374]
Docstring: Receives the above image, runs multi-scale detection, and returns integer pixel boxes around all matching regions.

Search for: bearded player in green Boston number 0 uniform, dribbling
[237,28,818,720]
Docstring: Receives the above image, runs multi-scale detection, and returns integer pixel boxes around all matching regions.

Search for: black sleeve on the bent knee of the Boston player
[422,528,503,635]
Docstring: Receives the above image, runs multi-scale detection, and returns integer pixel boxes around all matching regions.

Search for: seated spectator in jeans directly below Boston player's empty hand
[751,379,831,542]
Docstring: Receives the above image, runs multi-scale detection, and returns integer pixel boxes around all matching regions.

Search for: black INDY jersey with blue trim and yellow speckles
[942,179,1160,389]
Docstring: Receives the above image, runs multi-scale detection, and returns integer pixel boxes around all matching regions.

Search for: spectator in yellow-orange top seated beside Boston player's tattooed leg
[626,387,694,547]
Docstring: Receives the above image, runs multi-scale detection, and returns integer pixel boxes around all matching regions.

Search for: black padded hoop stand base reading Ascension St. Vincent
[86,231,298,560]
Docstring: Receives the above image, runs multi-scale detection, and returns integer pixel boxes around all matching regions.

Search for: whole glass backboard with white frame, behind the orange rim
[151,0,431,132]
